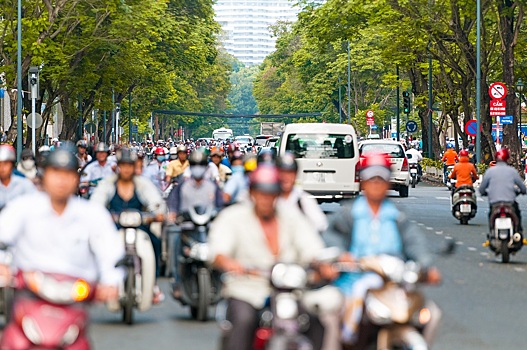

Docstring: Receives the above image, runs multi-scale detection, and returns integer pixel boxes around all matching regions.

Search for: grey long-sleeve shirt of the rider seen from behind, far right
[479,162,527,205]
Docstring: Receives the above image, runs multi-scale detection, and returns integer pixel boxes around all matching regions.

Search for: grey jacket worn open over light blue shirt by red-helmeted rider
[322,201,433,268]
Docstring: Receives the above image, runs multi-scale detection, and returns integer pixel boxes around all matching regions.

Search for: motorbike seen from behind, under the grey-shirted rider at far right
[486,202,524,263]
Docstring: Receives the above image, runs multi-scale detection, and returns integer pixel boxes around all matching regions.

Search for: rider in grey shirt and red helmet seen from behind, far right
[479,148,527,233]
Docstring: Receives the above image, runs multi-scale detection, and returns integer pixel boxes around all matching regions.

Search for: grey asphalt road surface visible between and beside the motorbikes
[12,184,527,350]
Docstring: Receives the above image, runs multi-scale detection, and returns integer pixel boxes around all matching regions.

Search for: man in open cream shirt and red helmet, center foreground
[209,165,324,350]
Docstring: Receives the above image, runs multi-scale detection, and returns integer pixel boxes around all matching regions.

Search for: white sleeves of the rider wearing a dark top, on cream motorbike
[90,174,166,214]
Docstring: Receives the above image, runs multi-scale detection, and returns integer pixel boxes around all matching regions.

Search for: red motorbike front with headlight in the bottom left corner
[0,271,95,349]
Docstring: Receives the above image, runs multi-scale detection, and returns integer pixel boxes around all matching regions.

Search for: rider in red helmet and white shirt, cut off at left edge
[0,145,36,209]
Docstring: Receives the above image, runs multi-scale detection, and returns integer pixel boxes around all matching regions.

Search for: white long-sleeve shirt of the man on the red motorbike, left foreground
[0,192,124,285]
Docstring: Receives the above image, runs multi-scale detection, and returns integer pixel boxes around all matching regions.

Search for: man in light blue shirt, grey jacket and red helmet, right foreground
[323,153,441,349]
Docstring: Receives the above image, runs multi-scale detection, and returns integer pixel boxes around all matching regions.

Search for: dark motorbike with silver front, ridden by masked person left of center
[175,206,221,321]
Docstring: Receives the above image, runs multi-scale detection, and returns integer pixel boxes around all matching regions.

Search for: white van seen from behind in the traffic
[278,123,360,202]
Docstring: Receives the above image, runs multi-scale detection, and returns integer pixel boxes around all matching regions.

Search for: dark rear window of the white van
[286,133,355,159]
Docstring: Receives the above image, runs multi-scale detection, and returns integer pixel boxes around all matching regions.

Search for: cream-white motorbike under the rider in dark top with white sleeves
[107,210,156,324]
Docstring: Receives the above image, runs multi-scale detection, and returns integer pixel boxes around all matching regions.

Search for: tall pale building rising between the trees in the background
[214,0,298,66]
